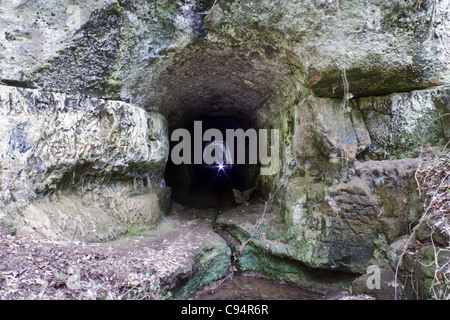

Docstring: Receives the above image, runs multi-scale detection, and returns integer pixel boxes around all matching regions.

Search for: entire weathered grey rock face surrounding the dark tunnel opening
[0,0,450,298]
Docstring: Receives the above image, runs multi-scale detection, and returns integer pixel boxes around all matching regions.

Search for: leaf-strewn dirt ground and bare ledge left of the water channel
[0,210,225,300]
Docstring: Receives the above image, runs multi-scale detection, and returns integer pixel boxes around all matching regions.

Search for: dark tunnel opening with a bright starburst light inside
[165,111,260,208]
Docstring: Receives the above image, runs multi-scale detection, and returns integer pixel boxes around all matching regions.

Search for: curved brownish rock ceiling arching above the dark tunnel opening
[156,44,297,127]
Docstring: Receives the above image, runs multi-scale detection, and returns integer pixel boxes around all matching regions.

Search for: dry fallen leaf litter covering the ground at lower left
[0,230,165,300]
